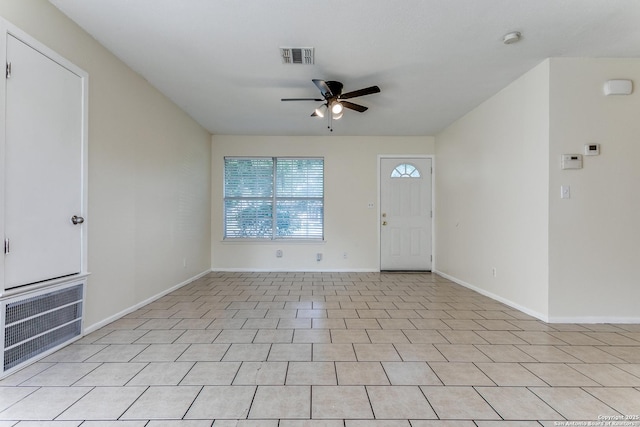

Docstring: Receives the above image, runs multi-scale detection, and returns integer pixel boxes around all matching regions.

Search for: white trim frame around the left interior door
[0,17,89,297]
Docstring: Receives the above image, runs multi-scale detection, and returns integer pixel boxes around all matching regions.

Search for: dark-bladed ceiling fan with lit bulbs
[282,79,380,132]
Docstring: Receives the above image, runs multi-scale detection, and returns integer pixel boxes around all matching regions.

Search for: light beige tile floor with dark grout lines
[0,273,640,427]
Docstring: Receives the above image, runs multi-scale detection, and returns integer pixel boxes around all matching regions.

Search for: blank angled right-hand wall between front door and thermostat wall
[434,61,549,318]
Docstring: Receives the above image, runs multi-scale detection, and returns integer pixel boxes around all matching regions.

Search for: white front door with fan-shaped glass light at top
[380,157,431,271]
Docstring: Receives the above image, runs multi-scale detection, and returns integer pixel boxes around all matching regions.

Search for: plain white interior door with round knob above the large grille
[4,36,83,288]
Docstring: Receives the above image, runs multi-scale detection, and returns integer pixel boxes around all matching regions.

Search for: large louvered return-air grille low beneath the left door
[3,284,84,372]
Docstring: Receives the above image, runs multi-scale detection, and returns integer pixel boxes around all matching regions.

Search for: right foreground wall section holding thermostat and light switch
[549,59,640,322]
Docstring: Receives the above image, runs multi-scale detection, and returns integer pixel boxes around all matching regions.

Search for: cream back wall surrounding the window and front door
[211,135,434,271]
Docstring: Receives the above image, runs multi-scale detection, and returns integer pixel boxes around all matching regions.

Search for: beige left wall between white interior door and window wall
[0,0,211,328]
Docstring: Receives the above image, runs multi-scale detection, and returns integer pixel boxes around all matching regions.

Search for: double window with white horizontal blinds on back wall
[224,157,324,240]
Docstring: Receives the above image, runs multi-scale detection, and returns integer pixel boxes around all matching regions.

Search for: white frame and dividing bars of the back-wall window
[222,156,325,242]
